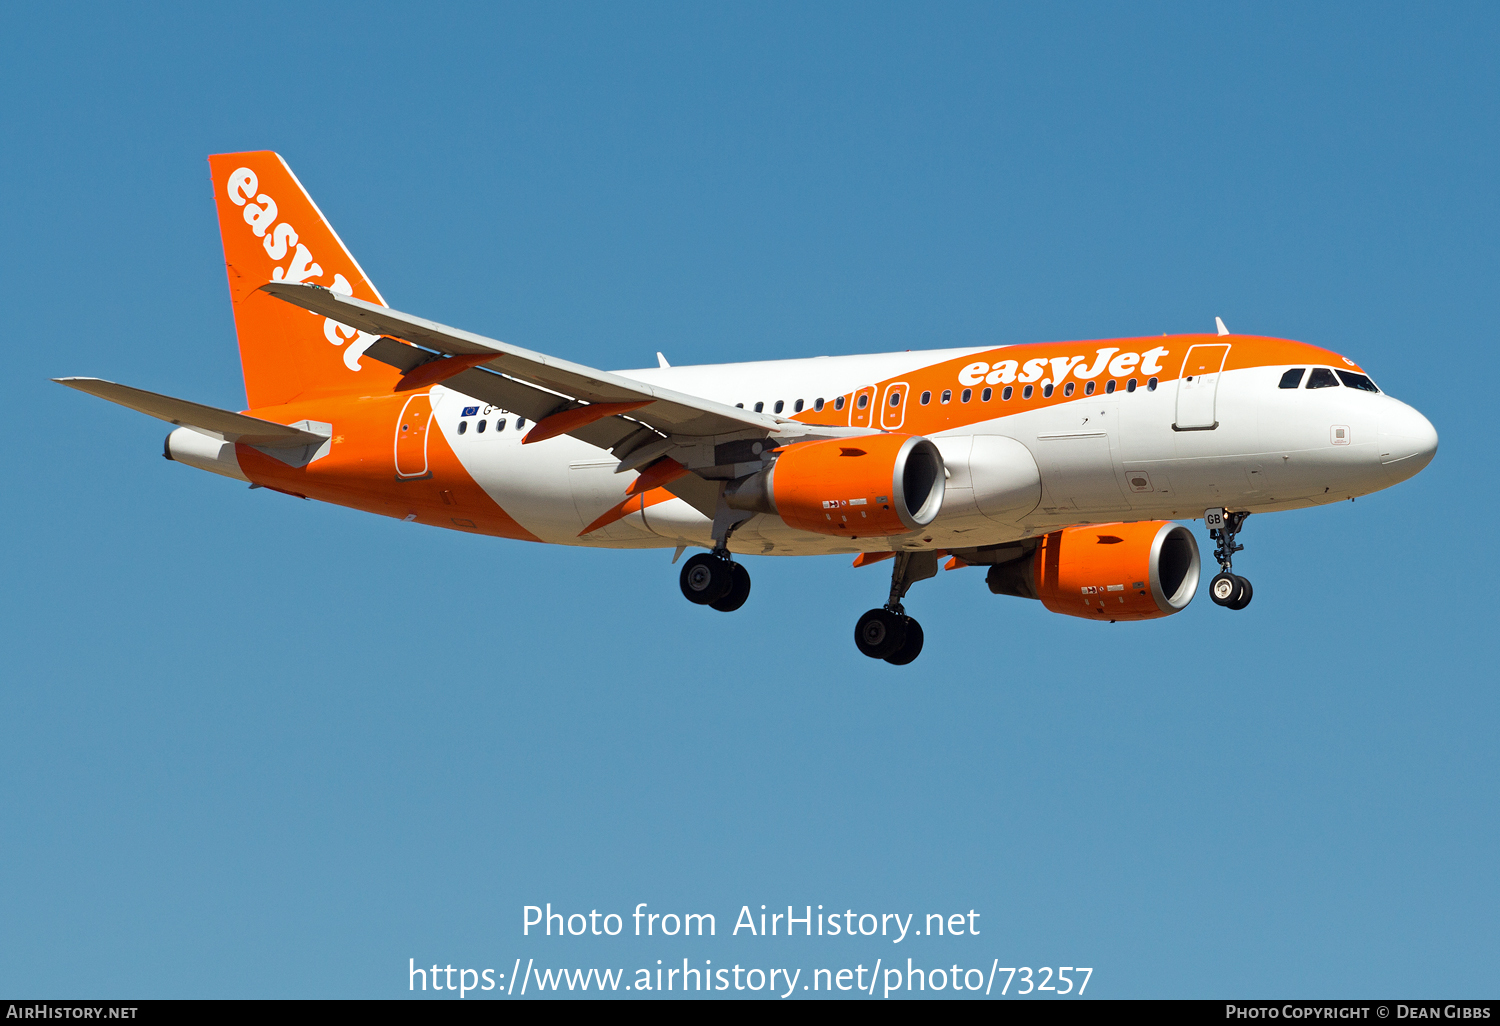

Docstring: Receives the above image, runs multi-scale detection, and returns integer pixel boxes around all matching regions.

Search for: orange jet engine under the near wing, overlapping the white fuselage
[725,435,947,539]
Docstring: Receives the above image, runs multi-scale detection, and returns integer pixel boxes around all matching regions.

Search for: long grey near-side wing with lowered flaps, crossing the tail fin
[261,282,786,449]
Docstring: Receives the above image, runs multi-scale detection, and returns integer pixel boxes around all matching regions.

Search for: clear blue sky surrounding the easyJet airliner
[0,5,1500,998]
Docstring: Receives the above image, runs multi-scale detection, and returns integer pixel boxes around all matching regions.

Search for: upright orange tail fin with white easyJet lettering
[209,150,401,410]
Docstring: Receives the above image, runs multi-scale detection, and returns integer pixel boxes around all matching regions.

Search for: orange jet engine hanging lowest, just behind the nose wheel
[987,521,1200,621]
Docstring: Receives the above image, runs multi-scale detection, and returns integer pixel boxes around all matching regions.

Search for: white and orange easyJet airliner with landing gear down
[59,152,1437,665]
